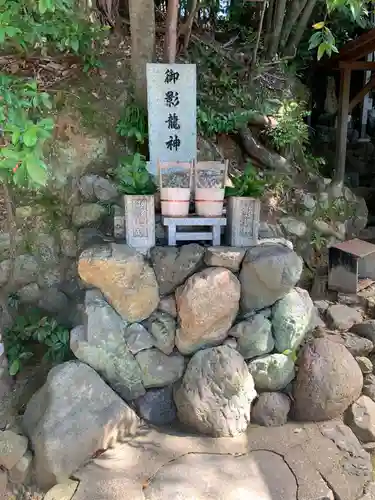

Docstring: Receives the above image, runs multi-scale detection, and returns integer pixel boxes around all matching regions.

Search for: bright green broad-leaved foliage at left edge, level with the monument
[0,74,54,188]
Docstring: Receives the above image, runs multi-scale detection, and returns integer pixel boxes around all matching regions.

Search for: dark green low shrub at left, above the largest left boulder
[4,311,71,376]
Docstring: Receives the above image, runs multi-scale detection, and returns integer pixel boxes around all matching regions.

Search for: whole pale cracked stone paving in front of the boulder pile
[73,420,372,500]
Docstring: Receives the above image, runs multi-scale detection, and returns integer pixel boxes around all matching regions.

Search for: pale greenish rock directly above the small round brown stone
[248,354,295,391]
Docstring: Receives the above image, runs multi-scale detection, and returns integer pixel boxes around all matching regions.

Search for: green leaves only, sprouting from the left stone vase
[115,153,157,195]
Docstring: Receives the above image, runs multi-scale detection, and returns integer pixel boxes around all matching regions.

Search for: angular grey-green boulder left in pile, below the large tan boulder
[70,290,145,401]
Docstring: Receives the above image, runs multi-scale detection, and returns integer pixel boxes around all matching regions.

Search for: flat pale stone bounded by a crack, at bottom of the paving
[143,451,296,500]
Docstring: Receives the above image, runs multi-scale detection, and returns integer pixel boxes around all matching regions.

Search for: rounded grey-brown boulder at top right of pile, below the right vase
[240,245,303,312]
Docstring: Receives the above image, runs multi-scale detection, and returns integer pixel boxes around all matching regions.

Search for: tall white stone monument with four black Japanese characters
[147,63,197,175]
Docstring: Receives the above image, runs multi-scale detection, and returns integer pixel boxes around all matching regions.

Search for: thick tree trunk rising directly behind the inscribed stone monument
[129,0,155,108]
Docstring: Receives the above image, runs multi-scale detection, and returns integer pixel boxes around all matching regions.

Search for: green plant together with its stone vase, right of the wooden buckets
[225,162,265,247]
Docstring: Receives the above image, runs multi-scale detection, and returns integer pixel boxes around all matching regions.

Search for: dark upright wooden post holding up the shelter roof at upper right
[334,68,352,185]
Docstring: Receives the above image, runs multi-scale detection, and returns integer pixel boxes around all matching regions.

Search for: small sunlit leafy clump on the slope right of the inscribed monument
[267,100,309,152]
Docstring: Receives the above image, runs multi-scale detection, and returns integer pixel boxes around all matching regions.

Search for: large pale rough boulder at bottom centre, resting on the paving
[175,346,256,436]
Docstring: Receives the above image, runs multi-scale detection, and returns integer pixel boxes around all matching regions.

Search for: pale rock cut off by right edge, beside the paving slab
[345,396,375,443]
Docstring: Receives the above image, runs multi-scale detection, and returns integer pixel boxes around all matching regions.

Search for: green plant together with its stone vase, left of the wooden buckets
[115,153,157,253]
